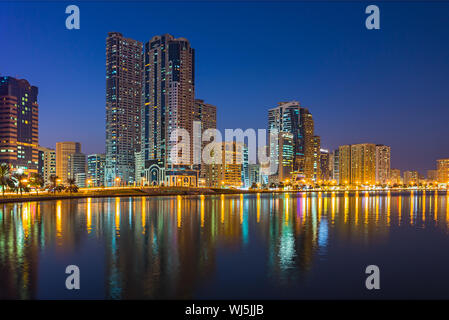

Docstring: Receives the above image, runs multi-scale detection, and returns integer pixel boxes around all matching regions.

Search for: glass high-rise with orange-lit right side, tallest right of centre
[268,101,319,182]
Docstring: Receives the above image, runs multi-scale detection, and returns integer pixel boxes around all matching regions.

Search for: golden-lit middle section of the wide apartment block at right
[351,143,376,185]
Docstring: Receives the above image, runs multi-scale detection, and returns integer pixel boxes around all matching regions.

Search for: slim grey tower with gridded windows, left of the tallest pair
[105,32,143,186]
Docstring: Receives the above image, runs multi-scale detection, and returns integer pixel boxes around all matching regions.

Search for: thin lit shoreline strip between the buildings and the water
[0,187,442,203]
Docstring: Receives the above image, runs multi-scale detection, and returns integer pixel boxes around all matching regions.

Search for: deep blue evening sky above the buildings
[0,1,449,173]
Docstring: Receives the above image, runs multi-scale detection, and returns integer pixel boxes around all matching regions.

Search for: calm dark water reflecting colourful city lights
[0,192,449,299]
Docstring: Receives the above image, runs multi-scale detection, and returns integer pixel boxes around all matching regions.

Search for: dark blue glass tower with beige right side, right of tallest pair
[142,34,195,168]
